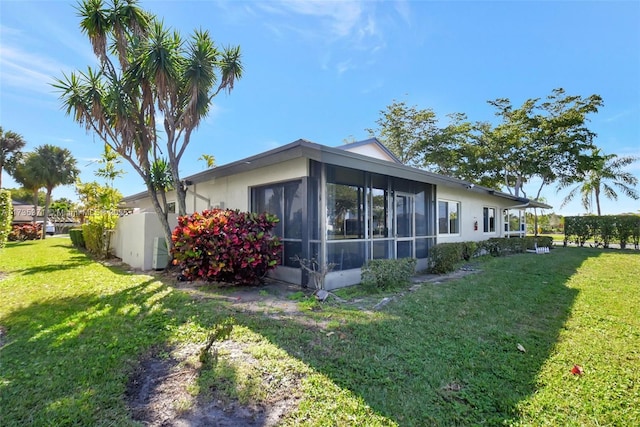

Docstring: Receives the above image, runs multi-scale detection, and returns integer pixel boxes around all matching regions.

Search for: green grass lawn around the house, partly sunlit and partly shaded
[0,238,640,426]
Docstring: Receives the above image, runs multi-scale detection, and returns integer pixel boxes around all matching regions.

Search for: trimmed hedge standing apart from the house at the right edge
[564,215,640,249]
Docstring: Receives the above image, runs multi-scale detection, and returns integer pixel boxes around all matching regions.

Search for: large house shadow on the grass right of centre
[225,249,600,426]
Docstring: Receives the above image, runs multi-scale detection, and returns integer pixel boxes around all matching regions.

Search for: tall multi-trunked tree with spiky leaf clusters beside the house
[54,0,243,254]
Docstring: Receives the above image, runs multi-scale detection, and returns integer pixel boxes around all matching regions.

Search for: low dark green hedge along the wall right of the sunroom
[429,236,553,274]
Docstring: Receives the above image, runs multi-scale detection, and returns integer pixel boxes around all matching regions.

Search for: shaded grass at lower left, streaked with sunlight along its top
[0,279,201,425]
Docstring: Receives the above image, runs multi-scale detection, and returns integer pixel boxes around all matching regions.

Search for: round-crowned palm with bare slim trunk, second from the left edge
[34,144,80,239]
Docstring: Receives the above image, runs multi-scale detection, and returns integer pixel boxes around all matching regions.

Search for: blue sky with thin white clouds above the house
[0,0,640,215]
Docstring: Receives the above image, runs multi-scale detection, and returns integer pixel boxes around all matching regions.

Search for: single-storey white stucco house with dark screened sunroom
[113,139,550,289]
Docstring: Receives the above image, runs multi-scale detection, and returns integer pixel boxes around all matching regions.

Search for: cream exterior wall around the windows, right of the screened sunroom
[436,186,516,243]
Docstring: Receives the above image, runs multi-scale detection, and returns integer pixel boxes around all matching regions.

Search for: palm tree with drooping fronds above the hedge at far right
[558,149,640,216]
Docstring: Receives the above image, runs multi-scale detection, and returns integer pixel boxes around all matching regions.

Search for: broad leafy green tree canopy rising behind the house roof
[369,89,603,203]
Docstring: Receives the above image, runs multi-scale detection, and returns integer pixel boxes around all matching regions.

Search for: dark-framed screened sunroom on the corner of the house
[251,161,436,287]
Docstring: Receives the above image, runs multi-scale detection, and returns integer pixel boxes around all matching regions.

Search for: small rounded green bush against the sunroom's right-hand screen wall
[361,258,416,291]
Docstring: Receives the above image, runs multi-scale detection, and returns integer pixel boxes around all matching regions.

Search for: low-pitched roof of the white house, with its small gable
[122,138,551,209]
